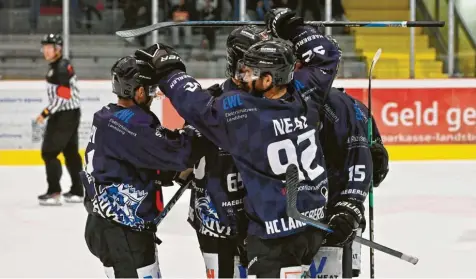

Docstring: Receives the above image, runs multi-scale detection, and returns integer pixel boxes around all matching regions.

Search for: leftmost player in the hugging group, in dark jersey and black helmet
[81,56,199,278]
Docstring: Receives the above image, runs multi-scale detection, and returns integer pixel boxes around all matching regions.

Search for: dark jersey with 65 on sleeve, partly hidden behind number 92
[188,79,247,237]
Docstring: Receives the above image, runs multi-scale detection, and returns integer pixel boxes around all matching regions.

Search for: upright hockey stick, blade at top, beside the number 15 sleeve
[367,48,382,278]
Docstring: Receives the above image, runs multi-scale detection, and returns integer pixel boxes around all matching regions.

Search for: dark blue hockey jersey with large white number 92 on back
[160,80,327,238]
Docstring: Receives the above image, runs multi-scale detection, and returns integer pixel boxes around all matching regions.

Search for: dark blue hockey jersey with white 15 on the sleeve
[320,88,380,205]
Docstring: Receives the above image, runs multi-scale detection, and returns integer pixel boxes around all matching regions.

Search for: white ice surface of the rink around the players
[0,161,476,278]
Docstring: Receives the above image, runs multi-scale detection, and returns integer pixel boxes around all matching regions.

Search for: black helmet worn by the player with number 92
[240,39,296,86]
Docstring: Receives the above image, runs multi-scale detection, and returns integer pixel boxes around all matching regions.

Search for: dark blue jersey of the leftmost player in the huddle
[82,104,192,230]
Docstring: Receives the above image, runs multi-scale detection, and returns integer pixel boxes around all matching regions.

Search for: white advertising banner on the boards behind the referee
[0,81,162,150]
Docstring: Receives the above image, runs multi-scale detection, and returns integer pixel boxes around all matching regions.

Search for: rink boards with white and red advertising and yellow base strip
[0,79,476,165]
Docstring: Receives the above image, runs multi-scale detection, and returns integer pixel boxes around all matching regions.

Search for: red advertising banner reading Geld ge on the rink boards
[163,87,476,145]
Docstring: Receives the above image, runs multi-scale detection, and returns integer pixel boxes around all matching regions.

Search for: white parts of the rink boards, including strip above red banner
[0,79,476,149]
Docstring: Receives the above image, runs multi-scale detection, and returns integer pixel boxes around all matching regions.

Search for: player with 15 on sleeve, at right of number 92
[310,88,388,278]
